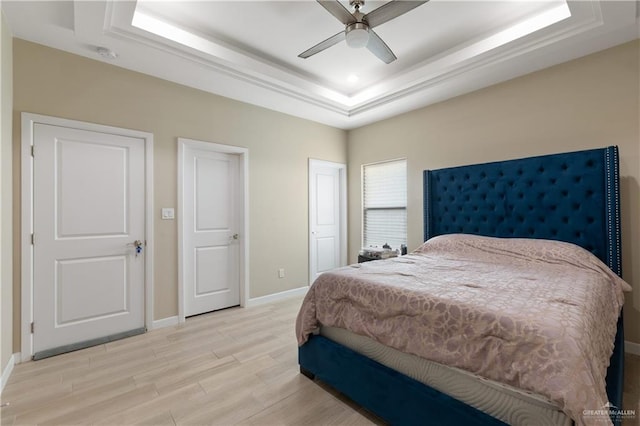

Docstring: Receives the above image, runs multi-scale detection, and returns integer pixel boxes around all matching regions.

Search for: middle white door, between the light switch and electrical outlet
[182,146,241,316]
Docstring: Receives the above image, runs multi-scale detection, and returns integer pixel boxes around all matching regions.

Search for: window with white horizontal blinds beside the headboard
[362,160,407,250]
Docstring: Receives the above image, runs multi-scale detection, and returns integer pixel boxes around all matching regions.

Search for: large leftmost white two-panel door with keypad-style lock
[33,124,145,358]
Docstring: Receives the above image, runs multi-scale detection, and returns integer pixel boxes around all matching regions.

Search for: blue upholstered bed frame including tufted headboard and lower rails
[299,147,624,425]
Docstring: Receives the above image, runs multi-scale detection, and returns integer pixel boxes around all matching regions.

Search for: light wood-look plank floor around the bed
[0,298,640,426]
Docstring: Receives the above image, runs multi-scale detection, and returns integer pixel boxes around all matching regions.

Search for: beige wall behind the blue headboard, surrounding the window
[348,41,640,343]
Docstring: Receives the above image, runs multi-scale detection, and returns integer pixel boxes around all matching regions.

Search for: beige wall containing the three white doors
[13,39,346,350]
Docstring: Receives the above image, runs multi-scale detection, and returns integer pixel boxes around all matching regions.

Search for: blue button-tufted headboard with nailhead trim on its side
[424,146,622,275]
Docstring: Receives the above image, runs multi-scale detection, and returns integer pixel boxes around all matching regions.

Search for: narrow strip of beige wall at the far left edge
[0,11,13,373]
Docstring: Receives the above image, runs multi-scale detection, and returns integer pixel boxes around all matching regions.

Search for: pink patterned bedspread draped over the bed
[296,234,631,425]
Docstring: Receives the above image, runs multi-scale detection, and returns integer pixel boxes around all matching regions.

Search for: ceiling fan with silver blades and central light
[298,0,429,64]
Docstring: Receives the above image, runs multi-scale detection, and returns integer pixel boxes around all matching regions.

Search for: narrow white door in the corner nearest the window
[309,160,346,283]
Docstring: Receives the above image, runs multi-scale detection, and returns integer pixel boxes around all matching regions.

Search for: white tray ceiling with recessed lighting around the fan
[2,0,640,129]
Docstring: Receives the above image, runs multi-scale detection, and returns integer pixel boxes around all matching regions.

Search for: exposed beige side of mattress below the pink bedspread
[320,326,573,426]
